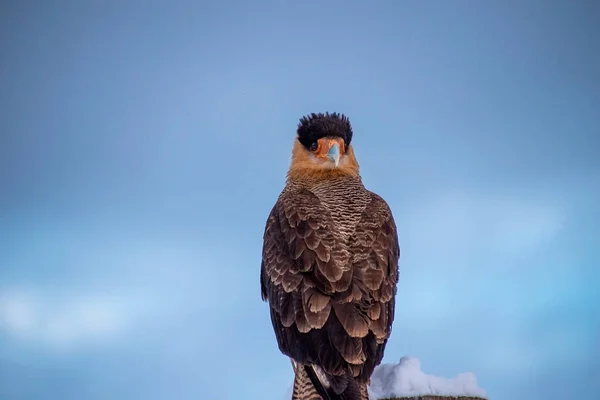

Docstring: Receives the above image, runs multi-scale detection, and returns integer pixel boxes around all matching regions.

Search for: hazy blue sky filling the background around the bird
[0,0,600,400]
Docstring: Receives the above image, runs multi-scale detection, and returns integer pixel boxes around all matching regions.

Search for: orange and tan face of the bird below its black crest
[287,137,359,181]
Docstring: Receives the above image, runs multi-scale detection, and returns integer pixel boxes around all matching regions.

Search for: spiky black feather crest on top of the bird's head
[298,113,352,149]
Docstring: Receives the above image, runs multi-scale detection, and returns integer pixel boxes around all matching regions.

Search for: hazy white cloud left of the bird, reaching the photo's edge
[0,231,254,350]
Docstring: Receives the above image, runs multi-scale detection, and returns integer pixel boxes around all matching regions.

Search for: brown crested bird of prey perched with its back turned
[260,112,400,400]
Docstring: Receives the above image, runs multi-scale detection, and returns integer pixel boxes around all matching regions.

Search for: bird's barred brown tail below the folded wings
[292,362,369,400]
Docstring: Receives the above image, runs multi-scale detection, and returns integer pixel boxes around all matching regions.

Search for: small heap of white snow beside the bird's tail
[369,357,487,399]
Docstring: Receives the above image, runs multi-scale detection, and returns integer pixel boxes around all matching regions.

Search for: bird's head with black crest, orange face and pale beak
[288,113,359,179]
